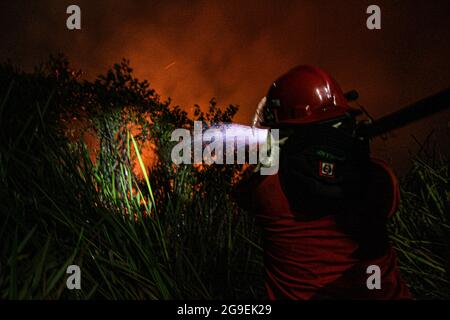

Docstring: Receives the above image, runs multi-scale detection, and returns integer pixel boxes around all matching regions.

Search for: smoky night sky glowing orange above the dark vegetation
[0,0,450,172]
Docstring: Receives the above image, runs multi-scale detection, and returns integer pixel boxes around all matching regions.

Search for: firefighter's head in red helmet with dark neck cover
[253,65,370,215]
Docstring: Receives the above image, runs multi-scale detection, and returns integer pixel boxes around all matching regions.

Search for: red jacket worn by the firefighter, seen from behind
[237,160,410,299]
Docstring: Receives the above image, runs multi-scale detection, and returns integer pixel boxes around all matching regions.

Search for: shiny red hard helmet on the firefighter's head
[253,65,361,127]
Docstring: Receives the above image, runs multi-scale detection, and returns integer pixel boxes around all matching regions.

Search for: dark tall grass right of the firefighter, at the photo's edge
[389,149,450,299]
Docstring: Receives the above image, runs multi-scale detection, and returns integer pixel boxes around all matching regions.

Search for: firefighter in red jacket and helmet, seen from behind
[236,66,410,300]
